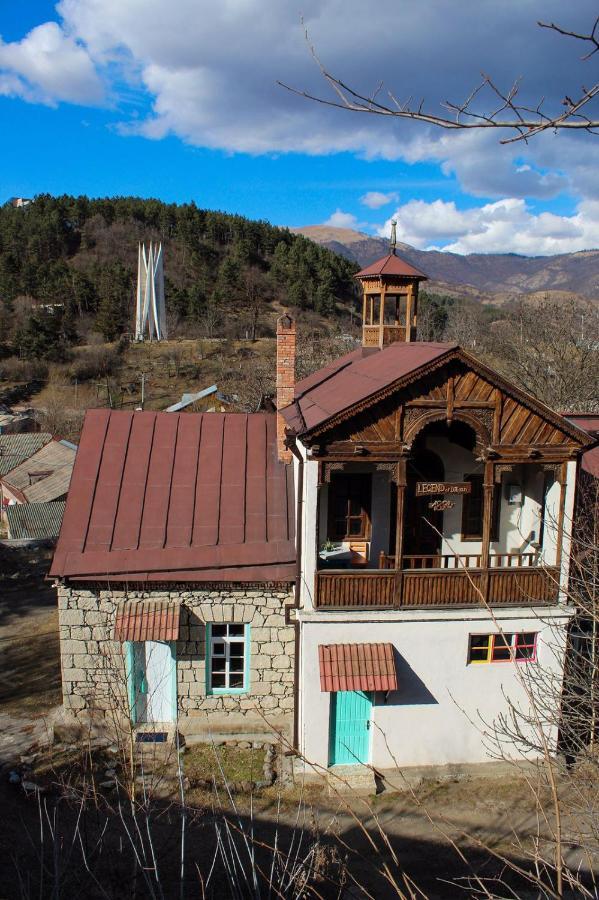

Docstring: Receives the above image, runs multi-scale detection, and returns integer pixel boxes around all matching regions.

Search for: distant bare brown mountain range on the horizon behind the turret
[292,225,599,303]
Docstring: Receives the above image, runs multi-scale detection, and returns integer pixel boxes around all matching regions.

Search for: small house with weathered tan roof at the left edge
[0,435,77,507]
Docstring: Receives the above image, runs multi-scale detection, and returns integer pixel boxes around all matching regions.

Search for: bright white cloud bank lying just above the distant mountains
[378,197,599,256]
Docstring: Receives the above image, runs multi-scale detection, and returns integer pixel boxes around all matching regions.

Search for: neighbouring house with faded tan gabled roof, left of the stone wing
[0,434,77,508]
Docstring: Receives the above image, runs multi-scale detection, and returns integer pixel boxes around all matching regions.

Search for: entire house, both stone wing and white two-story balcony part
[51,248,594,768]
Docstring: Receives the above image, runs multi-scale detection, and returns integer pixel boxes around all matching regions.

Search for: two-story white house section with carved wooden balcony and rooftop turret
[282,248,592,768]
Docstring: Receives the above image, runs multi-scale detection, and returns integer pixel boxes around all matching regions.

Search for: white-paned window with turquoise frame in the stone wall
[206,624,249,693]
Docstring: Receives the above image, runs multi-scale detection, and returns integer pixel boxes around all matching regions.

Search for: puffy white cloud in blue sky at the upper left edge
[0,22,104,105]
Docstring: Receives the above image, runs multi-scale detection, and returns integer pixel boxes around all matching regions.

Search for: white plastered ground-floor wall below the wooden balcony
[301,607,569,768]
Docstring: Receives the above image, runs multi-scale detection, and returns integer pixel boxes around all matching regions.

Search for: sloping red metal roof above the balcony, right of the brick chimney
[281,341,457,434]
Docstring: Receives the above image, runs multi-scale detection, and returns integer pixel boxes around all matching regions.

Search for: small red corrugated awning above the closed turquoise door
[318,644,397,691]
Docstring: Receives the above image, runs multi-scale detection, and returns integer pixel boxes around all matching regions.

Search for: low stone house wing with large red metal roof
[51,410,295,737]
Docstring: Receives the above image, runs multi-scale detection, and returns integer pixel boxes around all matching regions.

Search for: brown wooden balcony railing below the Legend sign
[316,560,559,609]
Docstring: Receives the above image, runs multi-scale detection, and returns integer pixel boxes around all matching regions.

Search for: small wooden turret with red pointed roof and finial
[355,222,426,348]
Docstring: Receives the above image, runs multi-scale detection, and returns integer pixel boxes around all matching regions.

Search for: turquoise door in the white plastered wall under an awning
[329,691,372,766]
